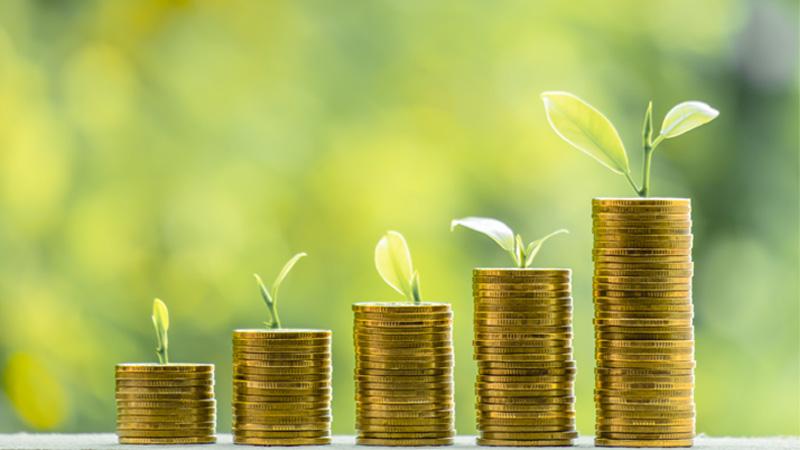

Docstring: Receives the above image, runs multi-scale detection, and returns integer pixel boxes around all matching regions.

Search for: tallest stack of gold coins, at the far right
[592,198,695,447]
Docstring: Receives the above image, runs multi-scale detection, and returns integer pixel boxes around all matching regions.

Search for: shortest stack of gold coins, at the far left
[116,364,217,445]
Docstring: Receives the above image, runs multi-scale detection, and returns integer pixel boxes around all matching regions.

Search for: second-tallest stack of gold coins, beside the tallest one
[472,269,578,447]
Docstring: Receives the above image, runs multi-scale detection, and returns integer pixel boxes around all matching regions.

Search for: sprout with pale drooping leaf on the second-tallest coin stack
[450,217,569,269]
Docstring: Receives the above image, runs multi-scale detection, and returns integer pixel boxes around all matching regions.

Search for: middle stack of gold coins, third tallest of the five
[353,303,455,446]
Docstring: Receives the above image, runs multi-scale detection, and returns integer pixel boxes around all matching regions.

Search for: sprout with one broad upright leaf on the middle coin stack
[375,231,422,305]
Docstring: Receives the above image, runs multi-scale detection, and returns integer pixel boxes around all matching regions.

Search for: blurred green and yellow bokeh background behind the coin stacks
[0,0,800,435]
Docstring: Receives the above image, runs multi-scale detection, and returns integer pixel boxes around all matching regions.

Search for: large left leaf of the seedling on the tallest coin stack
[542,92,630,174]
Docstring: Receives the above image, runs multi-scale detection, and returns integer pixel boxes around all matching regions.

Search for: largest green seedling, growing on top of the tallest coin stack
[542,92,719,197]
